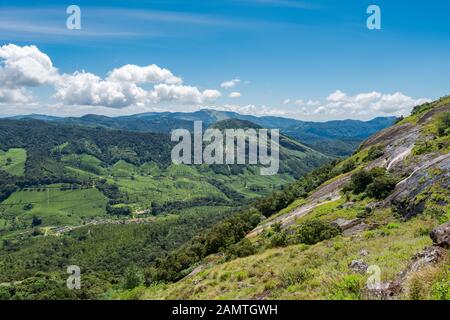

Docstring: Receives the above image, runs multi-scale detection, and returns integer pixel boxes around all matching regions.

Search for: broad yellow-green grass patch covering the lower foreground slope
[125,212,440,299]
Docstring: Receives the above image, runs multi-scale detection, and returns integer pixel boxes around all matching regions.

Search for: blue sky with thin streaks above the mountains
[0,0,450,120]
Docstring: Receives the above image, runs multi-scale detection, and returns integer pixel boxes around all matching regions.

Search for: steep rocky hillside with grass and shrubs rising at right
[113,97,450,300]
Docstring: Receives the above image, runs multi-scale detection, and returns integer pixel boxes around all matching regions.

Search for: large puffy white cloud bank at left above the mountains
[0,44,221,108]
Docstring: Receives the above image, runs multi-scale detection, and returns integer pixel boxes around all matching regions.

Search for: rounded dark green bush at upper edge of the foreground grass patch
[297,220,340,244]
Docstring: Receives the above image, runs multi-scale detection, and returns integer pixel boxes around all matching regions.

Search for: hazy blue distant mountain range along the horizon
[5,109,395,157]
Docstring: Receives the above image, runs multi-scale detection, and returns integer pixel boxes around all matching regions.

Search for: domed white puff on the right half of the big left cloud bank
[107,64,183,85]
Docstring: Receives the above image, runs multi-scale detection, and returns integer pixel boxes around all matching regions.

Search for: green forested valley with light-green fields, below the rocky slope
[0,119,338,299]
